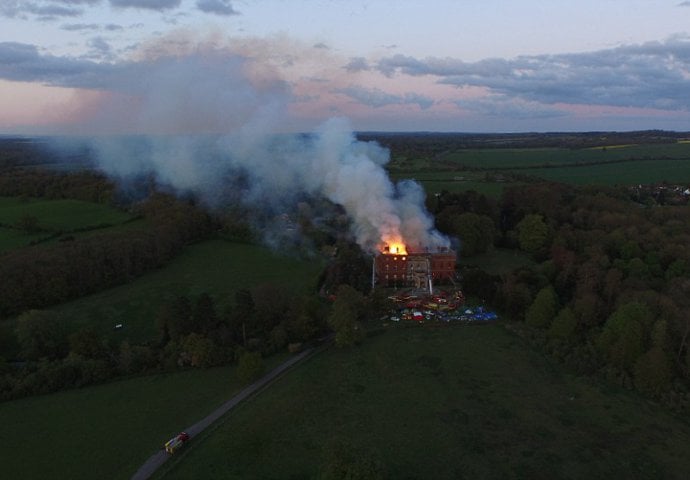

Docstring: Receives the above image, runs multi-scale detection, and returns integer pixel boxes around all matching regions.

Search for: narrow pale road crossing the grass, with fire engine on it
[132,346,322,480]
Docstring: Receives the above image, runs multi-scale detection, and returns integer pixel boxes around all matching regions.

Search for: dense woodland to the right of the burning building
[432,183,690,407]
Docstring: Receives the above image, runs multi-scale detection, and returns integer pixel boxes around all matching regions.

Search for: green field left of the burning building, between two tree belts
[44,240,321,342]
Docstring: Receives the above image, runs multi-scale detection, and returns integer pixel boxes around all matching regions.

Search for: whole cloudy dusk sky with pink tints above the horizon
[0,0,690,135]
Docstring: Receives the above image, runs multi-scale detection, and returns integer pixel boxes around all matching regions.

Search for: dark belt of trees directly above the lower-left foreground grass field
[0,284,329,400]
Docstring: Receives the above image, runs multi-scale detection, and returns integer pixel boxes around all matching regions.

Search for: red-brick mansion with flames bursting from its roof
[372,244,457,290]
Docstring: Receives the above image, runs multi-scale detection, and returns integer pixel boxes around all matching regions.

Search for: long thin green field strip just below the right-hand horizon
[440,143,690,169]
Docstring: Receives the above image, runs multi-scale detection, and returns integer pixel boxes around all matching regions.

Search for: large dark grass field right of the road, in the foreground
[157,325,690,480]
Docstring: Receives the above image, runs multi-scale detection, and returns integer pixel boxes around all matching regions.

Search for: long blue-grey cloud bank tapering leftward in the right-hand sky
[376,36,690,110]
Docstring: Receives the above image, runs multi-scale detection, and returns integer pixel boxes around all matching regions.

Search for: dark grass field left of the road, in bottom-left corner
[0,356,284,480]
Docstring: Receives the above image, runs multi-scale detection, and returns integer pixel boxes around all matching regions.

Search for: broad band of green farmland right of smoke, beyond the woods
[389,142,690,198]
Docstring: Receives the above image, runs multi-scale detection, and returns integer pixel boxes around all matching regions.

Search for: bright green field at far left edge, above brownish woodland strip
[0,197,136,253]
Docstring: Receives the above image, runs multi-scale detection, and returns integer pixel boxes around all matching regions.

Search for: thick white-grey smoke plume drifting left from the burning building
[74,40,449,252]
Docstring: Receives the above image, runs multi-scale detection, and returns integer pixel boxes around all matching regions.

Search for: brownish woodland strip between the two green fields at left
[0,194,217,319]
